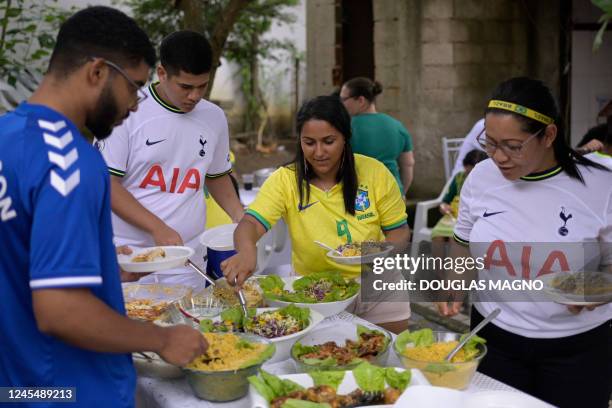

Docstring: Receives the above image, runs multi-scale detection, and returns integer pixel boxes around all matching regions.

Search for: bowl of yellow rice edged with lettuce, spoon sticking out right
[393,329,487,390]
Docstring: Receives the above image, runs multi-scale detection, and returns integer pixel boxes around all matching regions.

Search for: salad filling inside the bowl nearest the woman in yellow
[259,272,360,303]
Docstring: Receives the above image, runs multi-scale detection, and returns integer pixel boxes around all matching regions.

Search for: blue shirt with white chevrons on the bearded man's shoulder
[0,103,136,407]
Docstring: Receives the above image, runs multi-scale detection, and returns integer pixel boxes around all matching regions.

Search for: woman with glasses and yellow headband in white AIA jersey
[438,78,612,408]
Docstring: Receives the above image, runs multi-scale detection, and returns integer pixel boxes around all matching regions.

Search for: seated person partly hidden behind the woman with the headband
[431,149,487,242]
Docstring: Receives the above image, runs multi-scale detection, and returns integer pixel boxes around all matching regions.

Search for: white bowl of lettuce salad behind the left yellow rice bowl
[200,305,323,363]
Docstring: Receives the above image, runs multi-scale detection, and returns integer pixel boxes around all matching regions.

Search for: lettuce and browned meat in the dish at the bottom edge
[248,362,411,408]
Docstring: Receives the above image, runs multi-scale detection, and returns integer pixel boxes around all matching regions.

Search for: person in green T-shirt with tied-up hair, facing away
[340,77,414,197]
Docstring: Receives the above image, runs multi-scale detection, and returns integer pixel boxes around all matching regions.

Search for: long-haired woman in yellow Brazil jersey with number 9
[222,96,410,331]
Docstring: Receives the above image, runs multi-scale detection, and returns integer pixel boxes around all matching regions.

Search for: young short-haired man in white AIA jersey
[98,31,243,284]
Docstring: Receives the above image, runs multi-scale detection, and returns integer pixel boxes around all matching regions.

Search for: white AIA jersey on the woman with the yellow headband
[455,159,612,338]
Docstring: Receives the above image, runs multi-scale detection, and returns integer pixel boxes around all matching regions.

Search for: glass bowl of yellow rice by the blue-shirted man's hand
[183,333,275,402]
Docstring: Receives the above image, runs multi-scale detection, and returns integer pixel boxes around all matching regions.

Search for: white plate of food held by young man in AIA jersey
[117,246,194,273]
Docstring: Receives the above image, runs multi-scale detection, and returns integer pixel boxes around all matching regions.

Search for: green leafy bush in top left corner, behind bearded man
[0,0,73,86]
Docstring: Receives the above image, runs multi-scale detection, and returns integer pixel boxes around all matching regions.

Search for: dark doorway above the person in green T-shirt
[334,0,375,86]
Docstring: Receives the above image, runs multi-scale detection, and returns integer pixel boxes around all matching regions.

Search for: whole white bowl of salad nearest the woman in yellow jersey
[259,272,361,317]
